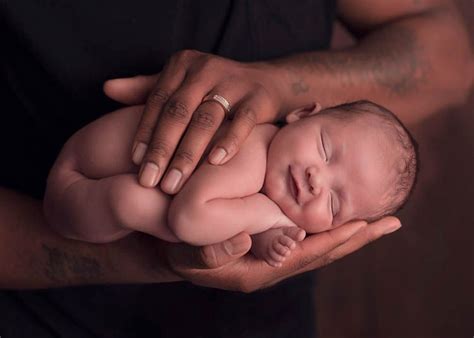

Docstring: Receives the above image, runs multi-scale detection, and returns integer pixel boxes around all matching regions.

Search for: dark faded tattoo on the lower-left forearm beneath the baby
[41,244,102,284]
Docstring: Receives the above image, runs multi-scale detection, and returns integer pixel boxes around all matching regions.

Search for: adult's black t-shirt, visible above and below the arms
[0,0,334,338]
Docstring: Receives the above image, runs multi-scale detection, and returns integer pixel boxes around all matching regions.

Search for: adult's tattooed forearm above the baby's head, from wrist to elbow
[264,9,473,124]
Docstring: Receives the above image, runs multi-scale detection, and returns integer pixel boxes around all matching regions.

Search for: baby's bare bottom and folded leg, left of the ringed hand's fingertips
[44,107,178,242]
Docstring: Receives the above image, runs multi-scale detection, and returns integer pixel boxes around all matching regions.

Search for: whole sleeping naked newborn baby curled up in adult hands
[44,101,417,266]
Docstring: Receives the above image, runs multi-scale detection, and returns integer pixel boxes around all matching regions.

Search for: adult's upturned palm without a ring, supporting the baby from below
[164,216,401,293]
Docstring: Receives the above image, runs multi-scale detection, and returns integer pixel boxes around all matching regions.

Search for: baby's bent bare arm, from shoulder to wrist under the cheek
[168,126,306,245]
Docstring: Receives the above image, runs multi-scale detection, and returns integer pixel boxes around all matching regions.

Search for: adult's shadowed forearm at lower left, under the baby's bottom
[0,188,179,289]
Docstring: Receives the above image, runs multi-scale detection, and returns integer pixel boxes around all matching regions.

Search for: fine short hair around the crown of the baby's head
[319,100,419,222]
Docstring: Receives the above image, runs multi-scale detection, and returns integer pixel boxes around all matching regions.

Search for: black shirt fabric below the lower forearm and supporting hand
[0,274,315,338]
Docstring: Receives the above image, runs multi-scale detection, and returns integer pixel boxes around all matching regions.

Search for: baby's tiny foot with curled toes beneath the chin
[252,227,306,267]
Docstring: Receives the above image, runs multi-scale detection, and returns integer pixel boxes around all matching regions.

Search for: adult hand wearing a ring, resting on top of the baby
[104,50,281,194]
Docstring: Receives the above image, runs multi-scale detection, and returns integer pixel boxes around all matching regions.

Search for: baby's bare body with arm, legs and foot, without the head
[45,106,305,266]
